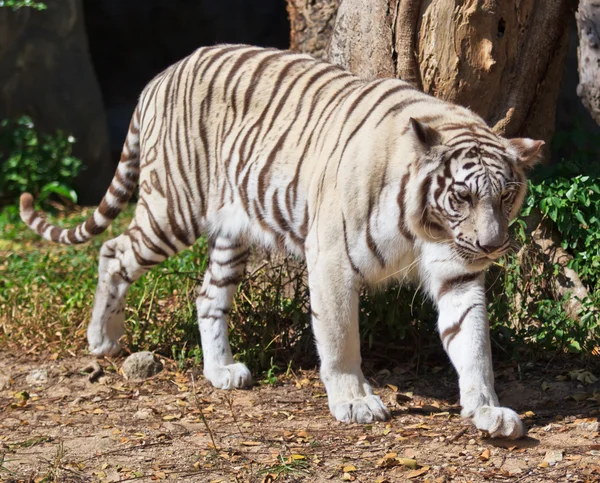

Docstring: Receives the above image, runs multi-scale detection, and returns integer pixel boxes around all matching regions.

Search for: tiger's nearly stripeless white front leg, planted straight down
[306,249,390,423]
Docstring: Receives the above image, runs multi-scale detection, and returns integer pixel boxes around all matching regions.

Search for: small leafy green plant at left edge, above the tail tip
[0,116,81,208]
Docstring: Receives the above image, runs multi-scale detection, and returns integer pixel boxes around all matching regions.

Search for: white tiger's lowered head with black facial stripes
[410,118,544,265]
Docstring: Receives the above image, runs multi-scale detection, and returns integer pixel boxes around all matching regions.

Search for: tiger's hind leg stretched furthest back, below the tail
[87,226,167,356]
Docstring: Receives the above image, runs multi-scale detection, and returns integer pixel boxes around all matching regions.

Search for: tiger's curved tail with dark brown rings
[20,109,140,245]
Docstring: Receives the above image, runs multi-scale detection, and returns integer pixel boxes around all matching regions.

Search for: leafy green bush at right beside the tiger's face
[490,125,600,353]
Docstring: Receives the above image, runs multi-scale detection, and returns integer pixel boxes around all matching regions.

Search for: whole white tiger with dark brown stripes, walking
[21,45,543,437]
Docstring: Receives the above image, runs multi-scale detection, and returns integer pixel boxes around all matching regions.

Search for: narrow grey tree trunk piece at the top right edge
[575,0,600,124]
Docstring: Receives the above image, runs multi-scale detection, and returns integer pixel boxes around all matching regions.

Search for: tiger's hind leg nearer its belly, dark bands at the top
[196,236,252,389]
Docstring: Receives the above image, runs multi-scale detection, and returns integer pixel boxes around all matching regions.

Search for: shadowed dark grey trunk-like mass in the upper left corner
[0,0,114,203]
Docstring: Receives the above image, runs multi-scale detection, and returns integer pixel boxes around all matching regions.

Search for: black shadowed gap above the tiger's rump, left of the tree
[83,0,290,163]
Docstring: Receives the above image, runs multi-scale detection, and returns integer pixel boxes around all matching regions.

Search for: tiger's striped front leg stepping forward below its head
[421,247,524,438]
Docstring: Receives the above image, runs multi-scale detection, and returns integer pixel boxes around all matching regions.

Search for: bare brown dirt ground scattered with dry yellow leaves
[0,353,600,483]
